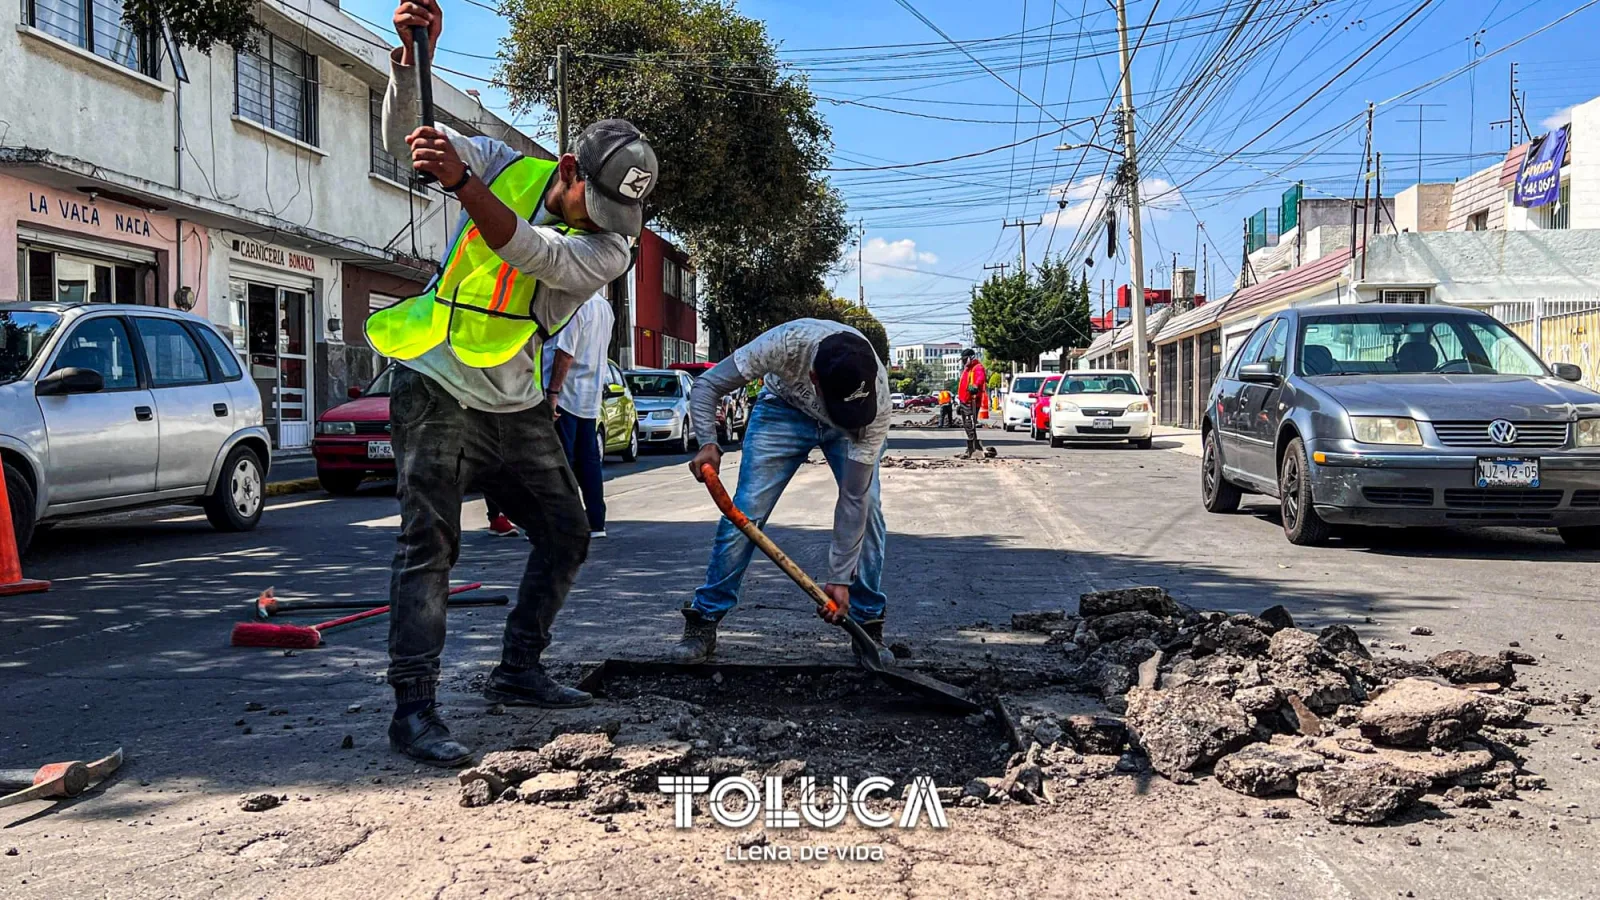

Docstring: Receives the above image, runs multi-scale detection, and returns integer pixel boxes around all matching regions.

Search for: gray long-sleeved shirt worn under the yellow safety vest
[384,58,629,413]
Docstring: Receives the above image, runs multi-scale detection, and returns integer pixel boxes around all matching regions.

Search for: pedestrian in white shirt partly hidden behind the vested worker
[544,293,614,538]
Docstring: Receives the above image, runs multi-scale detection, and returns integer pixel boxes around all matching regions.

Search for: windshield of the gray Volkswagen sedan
[1294,309,1547,376]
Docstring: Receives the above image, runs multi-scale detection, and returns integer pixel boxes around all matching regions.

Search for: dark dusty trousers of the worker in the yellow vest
[389,367,589,703]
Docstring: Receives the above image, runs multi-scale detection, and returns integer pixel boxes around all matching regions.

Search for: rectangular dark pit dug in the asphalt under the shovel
[603,666,1013,791]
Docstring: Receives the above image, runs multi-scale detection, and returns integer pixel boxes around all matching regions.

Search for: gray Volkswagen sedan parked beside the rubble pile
[1202,304,1600,548]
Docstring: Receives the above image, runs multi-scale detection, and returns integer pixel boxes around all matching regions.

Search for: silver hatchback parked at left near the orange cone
[0,303,272,549]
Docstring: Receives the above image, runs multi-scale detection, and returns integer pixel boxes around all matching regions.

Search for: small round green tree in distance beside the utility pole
[968,258,1090,368]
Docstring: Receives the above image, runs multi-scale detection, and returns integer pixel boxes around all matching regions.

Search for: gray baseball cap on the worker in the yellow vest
[574,119,661,237]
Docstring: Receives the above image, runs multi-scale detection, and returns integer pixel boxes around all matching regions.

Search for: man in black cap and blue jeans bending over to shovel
[670,319,890,663]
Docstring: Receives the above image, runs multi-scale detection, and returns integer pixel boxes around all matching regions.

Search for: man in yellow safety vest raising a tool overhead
[366,0,659,765]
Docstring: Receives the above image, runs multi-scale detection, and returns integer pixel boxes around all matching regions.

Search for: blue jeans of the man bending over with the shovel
[694,392,888,621]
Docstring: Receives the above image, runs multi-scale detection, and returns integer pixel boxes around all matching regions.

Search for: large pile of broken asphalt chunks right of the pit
[1011,588,1555,825]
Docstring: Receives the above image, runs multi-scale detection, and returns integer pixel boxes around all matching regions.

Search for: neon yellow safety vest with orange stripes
[366,157,576,371]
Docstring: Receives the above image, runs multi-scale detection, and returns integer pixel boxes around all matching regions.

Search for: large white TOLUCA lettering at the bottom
[658,775,950,828]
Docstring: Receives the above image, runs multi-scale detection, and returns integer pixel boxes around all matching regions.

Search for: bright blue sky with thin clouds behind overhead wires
[342,0,1600,343]
